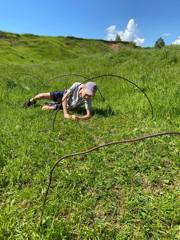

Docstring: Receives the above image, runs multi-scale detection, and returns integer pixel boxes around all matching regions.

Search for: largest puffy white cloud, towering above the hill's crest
[106,19,144,46]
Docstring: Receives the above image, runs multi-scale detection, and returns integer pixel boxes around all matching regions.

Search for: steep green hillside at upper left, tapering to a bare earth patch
[0,32,132,63]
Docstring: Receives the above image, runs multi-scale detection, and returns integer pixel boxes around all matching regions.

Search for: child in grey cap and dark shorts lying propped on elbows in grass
[24,82,97,120]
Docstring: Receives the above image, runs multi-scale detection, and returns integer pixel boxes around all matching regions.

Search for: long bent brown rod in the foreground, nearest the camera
[40,131,180,226]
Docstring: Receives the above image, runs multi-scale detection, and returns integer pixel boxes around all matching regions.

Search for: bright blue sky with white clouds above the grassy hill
[0,0,180,46]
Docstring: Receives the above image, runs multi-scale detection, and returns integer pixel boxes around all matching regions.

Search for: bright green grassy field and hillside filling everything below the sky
[0,32,180,240]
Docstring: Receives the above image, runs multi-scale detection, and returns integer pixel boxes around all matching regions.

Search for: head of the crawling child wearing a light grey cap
[80,82,97,100]
